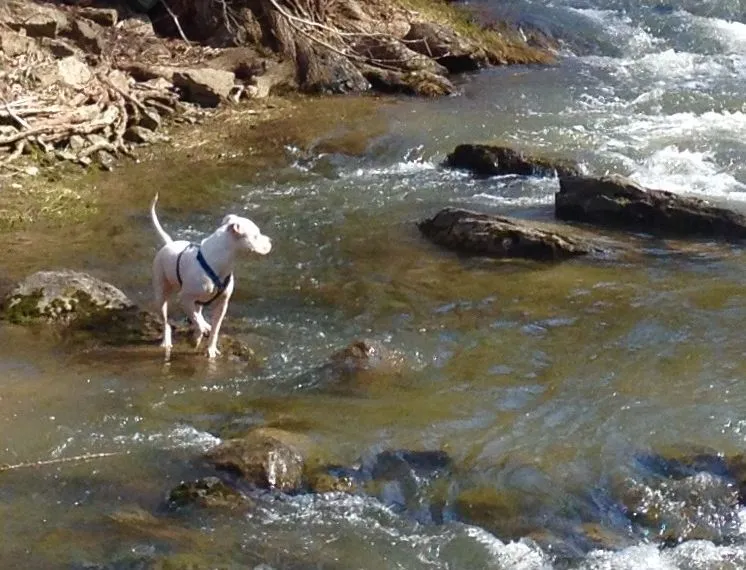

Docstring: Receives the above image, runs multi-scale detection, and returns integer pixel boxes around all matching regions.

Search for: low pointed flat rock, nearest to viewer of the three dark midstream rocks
[418,208,602,261]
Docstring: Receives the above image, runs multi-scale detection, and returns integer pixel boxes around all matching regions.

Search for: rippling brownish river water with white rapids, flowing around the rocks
[0,0,746,570]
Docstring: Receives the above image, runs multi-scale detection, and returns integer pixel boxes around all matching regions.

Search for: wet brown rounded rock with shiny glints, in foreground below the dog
[205,428,312,493]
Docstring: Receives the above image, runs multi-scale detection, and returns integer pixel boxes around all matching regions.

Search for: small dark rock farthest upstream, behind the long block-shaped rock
[445,144,580,176]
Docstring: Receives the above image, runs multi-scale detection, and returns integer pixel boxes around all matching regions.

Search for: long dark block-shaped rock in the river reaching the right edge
[555,175,746,239]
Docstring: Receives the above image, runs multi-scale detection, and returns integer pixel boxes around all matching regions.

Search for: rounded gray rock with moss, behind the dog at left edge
[0,270,134,323]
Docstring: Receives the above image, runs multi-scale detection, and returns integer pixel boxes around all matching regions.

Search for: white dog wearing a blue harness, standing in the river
[150,194,272,358]
